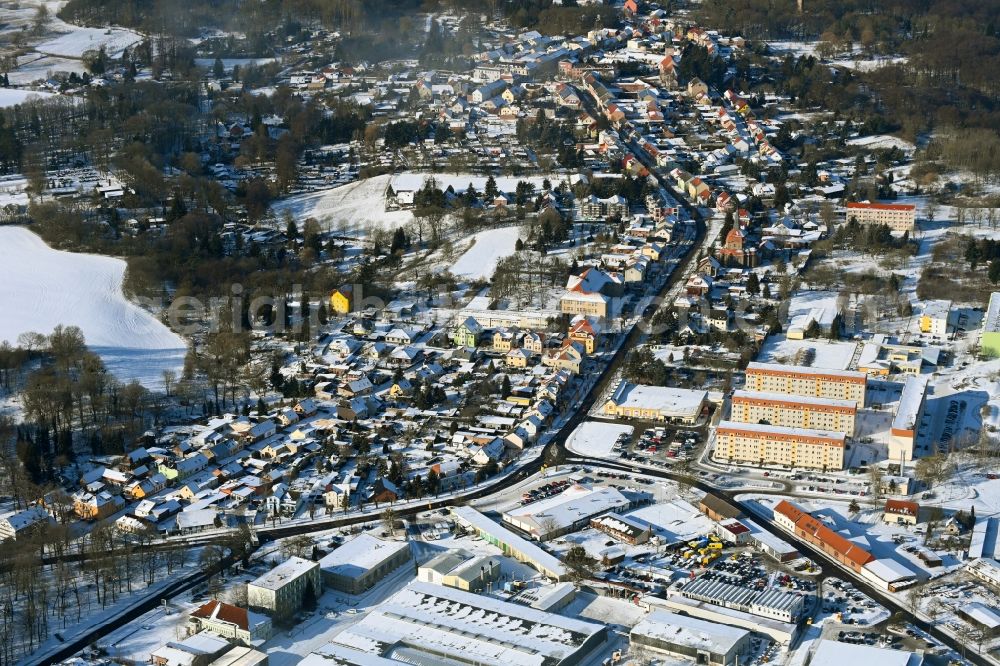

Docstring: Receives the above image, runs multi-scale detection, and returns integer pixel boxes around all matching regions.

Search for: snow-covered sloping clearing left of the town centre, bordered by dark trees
[271,175,413,235]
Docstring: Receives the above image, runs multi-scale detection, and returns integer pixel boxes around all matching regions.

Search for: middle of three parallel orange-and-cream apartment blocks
[730,391,858,437]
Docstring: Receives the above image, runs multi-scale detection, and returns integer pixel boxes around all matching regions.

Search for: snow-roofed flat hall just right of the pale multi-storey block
[319,534,412,594]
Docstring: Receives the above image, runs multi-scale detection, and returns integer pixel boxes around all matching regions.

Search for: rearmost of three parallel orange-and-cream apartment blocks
[744,362,867,406]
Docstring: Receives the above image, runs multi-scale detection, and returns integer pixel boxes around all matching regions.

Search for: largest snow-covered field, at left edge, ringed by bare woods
[0,227,186,387]
